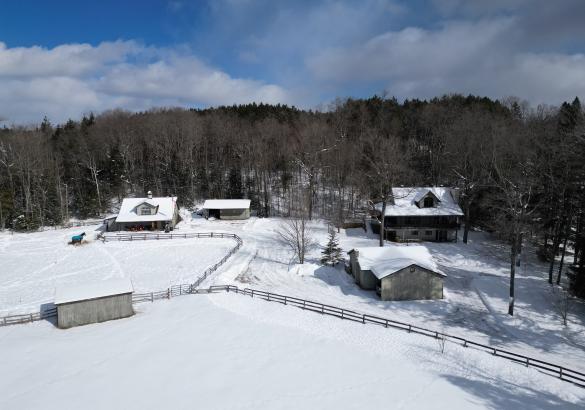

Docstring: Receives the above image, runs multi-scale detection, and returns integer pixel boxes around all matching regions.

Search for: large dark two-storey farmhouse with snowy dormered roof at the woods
[373,187,463,242]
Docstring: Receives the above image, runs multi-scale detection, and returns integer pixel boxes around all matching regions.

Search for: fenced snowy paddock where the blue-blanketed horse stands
[0,225,234,316]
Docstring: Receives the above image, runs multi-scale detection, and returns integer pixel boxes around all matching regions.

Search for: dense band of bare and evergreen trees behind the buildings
[0,95,585,302]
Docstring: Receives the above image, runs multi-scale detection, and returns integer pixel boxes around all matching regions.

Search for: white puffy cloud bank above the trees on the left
[0,41,289,124]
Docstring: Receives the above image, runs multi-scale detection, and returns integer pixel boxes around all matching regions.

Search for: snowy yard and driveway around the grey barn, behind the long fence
[175,218,585,371]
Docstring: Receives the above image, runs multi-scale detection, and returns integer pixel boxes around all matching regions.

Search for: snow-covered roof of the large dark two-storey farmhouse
[375,187,463,216]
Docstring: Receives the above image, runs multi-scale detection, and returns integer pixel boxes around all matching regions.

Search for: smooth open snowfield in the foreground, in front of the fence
[0,294,585,410]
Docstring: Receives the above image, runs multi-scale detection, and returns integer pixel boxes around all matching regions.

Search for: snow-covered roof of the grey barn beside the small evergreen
[350,245,446,279]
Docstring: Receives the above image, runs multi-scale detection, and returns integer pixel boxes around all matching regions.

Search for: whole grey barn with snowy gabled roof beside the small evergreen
[349,245,446,300]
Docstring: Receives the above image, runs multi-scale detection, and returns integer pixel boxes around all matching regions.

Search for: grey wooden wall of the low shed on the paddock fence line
[57,293,134,329]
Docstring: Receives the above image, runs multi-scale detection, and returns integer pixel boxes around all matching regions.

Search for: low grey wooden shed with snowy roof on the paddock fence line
[54,278,134,329]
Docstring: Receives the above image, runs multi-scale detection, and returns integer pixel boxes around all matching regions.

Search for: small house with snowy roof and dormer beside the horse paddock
[115,191,179,230]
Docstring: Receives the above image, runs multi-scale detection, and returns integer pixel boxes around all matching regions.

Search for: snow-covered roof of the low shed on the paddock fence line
[54,278,133,305]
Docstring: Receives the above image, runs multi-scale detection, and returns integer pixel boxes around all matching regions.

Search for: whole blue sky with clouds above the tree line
[0,0,585,124]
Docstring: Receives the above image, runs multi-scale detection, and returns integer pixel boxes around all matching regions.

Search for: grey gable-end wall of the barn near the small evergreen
[380,266,443,300]
